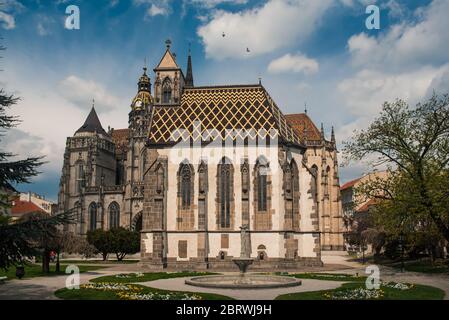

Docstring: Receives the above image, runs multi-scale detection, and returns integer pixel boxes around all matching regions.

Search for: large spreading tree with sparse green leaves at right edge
[344,95,449,245]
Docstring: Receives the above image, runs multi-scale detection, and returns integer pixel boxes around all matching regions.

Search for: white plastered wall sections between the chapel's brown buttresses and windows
[149,146,317,261]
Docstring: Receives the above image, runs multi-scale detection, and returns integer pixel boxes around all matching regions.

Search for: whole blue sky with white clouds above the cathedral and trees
[0,0,449,200]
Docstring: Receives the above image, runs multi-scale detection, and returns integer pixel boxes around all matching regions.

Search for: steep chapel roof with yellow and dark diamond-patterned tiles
[149,85,301,145]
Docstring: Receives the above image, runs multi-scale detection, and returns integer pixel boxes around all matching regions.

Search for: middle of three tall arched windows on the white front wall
[218,158,232,228]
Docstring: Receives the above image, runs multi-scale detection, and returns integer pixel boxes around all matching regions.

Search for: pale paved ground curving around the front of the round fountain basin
[139,277,344,300]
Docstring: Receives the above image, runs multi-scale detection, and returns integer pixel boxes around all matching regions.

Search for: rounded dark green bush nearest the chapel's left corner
[109,227,140,261]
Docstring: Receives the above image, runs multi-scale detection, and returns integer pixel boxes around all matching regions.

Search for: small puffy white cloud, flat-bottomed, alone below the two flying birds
[268,53,319,74]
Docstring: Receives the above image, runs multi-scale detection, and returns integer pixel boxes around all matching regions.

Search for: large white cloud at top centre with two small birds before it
[197,0,333,60]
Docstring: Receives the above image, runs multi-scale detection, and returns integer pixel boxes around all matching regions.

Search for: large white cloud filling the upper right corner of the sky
[348,0,449,69]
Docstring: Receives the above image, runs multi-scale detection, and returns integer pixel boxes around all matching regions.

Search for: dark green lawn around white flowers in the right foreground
[276,282,444,300]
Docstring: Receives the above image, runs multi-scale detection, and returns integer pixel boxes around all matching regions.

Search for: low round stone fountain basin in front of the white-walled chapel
[185,274,301,289]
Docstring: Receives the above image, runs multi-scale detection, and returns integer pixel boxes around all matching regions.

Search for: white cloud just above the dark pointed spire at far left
[59,75,124,112]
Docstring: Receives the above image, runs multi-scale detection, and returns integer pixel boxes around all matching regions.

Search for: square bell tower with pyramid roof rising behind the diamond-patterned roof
[154,40,185,105]
